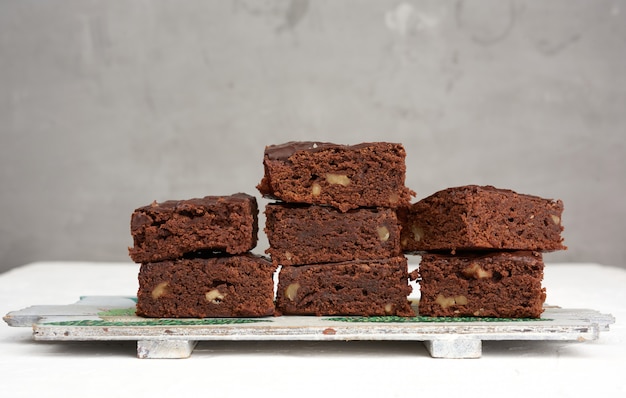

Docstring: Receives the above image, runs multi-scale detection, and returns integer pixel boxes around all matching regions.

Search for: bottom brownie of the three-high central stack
[276,256,415,316]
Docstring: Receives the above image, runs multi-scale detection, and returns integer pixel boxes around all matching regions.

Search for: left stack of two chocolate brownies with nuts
[129,193,276,318]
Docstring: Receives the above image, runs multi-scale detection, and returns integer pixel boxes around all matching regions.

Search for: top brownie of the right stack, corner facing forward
[398,185,566,252]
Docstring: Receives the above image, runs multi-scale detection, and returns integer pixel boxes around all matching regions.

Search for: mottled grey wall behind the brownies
[0,0,626,271]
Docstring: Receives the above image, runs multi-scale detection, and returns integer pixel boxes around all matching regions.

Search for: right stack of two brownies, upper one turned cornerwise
[398,185,565,318]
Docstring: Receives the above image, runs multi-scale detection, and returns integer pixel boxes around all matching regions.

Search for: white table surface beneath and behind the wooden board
[0,262,626,398]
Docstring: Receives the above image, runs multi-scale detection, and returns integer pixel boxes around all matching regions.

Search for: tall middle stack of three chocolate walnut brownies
[257,142,414,316]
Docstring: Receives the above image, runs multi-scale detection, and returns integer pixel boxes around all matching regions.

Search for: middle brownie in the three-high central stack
[265,203,402,265]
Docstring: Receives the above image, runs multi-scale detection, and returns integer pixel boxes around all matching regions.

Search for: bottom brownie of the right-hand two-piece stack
[411,251,546,318]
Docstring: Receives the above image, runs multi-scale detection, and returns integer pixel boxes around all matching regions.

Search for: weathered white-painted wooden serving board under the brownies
[4,296,615,358]
